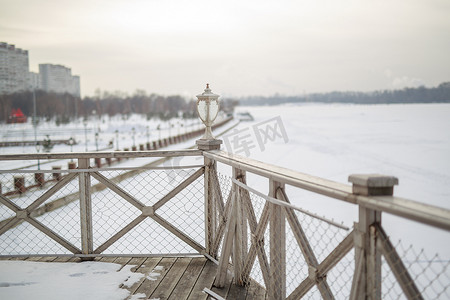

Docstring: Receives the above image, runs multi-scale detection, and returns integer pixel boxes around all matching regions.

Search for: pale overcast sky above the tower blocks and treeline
[0,0,450,96]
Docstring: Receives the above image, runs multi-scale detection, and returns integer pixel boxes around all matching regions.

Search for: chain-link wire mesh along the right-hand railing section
[211,174,450,299]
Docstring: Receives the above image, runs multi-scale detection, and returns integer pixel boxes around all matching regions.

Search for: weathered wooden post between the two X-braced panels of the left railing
[78,158,94,254]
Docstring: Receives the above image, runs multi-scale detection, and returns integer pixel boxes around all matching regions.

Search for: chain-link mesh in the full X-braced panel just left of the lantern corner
[92,169,205,254]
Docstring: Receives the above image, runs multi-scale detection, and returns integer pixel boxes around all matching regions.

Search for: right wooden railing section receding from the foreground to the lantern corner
[203,150,450,299]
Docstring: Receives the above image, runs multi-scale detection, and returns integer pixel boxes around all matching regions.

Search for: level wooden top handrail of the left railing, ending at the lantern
[0,149,202,160]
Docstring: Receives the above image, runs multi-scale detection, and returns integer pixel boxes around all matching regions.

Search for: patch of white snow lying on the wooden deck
[0,261,144,300]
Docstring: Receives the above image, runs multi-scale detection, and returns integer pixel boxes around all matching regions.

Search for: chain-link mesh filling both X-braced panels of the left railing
[0,167,205,255]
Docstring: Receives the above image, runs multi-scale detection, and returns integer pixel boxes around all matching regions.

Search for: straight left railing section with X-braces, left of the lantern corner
[0,150,204,258]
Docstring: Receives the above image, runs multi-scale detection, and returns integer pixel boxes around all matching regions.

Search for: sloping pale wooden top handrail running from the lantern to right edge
[203,150,450,231]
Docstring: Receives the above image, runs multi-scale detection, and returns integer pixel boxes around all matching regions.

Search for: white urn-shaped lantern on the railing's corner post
[197,84,219,140]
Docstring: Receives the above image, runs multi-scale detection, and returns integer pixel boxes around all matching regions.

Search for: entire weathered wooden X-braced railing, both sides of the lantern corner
[0,150,450,299]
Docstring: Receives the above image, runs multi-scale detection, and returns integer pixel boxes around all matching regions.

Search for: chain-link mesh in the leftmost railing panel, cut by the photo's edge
[0,171,80,255]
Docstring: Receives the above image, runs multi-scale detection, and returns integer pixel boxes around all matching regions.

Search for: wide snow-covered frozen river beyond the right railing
[225,104,450,259]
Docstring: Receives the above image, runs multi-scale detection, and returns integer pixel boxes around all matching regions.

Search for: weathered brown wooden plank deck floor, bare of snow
[0,256,266,300]
